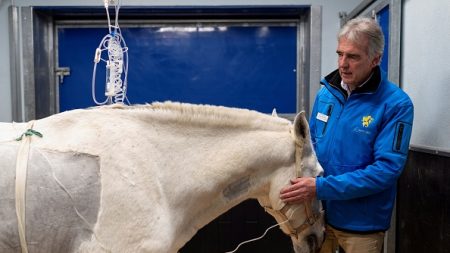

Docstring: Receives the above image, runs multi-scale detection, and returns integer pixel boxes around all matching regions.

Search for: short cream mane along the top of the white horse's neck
[94,101,291,130]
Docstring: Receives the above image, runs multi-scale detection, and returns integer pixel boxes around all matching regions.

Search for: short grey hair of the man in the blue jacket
[338,17,384,58]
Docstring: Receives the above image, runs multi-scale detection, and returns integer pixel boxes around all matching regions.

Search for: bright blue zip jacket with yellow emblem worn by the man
[310,67,414,232]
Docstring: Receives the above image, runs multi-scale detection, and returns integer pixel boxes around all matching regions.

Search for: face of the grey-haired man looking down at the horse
[336,38,380,89]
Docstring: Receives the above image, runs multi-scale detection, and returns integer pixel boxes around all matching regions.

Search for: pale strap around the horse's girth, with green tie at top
[15,120,42,253]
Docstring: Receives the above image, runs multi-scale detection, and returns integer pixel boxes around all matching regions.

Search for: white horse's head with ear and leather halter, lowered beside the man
[258,112,324,253]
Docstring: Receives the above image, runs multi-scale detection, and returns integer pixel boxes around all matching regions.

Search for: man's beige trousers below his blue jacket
[320,225,384,253]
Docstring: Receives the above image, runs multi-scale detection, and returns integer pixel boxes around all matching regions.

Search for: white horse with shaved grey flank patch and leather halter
[0,102,323,253]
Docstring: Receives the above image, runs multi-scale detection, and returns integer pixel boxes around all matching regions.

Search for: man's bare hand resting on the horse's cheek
[280,177,316,204]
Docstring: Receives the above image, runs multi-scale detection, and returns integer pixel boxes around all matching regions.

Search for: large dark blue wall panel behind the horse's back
[58,24,297,113]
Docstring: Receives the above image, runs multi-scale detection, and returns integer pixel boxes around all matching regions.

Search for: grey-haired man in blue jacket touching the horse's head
[280,18,413,253]
